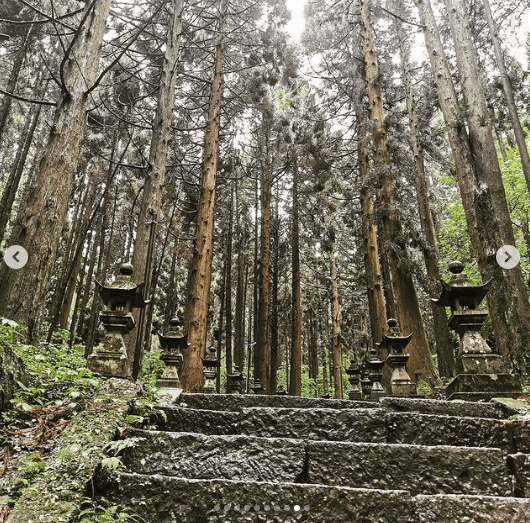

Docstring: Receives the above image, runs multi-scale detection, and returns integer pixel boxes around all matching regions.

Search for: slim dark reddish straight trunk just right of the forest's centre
[289,151,302,396]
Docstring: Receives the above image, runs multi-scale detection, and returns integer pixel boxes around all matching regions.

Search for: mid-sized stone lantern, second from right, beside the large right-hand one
[378,318,416,396]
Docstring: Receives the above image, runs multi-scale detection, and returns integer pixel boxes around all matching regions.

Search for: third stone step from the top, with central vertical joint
[123,431,512,496]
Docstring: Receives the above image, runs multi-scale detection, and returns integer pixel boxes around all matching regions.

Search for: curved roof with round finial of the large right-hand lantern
[431,261,492,312]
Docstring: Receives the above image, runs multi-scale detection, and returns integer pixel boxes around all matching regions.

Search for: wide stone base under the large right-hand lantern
[445,374,522,401]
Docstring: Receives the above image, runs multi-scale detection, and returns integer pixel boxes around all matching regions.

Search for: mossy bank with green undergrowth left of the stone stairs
[0,327,162,523]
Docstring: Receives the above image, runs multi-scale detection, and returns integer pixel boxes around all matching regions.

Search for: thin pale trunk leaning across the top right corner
[482,0,530,192]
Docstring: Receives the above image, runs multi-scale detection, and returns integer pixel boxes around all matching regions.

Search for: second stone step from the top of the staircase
[161,407,512,452]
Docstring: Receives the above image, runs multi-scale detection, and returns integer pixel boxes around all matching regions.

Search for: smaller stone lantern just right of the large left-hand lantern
[156,317,189,389]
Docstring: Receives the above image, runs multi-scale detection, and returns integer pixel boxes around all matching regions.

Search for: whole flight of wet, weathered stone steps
[95,394,530,523]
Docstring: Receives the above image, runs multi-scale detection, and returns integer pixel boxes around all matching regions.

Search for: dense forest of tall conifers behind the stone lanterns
[0,0,530,397]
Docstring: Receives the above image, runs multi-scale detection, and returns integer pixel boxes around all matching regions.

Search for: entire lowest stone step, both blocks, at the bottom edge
[96,473,530,523]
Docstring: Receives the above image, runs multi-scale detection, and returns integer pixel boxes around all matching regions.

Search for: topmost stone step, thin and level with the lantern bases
[178,393,517,419]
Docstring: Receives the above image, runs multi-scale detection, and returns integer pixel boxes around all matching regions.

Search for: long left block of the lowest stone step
[97,474,417,523]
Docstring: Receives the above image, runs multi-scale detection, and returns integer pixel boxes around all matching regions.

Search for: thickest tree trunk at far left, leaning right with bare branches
[0,0,111,340]
